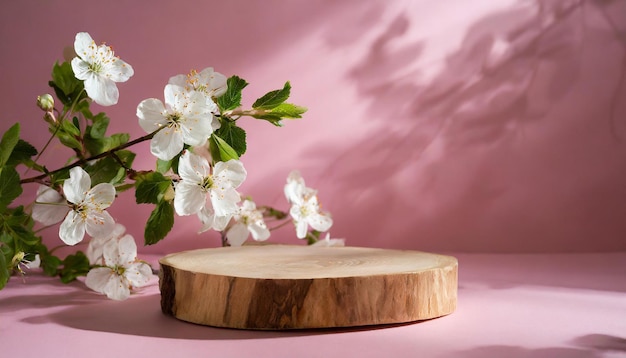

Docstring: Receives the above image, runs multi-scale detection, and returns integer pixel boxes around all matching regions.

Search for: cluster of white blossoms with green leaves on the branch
[0,32,344,300]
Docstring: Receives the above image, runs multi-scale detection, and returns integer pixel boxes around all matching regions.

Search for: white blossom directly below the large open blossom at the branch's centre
[174,151,247,217]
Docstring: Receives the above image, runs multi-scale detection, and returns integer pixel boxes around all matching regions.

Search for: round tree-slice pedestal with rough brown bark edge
[159,245,458,330]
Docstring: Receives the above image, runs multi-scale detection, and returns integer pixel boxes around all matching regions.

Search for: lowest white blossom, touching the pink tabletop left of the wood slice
[85,235,152,301]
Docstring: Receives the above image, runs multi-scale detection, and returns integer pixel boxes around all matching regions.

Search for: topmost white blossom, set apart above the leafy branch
[72,32,134,106]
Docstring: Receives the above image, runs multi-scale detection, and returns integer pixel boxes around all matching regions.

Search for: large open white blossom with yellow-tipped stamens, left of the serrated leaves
[137,84,219,160]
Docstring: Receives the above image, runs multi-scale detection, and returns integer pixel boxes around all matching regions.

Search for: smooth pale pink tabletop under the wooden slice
[0,253,626,358]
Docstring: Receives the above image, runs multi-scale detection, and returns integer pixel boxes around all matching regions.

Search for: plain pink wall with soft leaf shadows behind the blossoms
[0,0,626,253]
